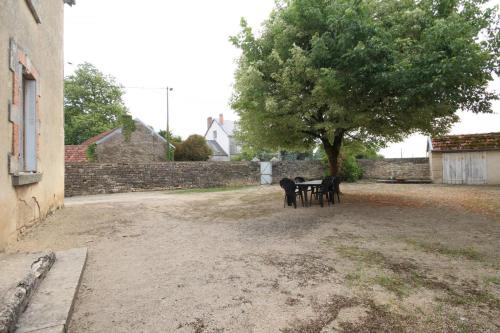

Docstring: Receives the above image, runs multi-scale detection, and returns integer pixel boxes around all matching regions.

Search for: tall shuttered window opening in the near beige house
[19,75,37,172]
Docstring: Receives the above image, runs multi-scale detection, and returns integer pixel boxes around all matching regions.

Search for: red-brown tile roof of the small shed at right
[432,132,500,151]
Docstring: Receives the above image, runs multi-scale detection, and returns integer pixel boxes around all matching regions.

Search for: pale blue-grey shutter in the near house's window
[24,80,37,172]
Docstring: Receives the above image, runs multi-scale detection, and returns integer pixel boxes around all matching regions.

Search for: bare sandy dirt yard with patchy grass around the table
[9,183,500,333]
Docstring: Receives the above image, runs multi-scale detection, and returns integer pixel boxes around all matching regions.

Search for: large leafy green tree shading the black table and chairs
[231,0,499,175]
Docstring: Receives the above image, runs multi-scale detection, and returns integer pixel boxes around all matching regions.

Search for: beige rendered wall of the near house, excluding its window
[0,0,64,251]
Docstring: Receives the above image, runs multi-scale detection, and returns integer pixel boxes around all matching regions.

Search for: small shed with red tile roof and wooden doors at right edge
[427,132,500,184]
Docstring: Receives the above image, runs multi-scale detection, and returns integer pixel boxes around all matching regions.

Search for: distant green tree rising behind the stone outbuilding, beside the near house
[64,63,135,145]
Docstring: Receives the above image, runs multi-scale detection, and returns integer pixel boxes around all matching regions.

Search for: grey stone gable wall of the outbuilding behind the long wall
[96,122,167,163]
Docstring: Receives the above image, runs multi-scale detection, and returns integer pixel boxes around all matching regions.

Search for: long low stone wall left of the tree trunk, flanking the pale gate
[65,161,323,196]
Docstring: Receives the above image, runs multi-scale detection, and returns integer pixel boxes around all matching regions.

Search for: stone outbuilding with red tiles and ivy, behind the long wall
[65,119,175,163]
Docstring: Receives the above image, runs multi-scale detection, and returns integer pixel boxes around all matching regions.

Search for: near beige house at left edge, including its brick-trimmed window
[0,0,74,251]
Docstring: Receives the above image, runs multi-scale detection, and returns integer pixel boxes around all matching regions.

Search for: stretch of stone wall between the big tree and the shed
[358,158,431,180]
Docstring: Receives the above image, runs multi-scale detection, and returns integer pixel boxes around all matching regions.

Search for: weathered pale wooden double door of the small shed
[443,152,486,185]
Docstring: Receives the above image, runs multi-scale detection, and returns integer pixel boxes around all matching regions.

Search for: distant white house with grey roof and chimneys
[205,113,241,161]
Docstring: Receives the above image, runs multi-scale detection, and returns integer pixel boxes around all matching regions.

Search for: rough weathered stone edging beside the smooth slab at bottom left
[0,252,56,333]
